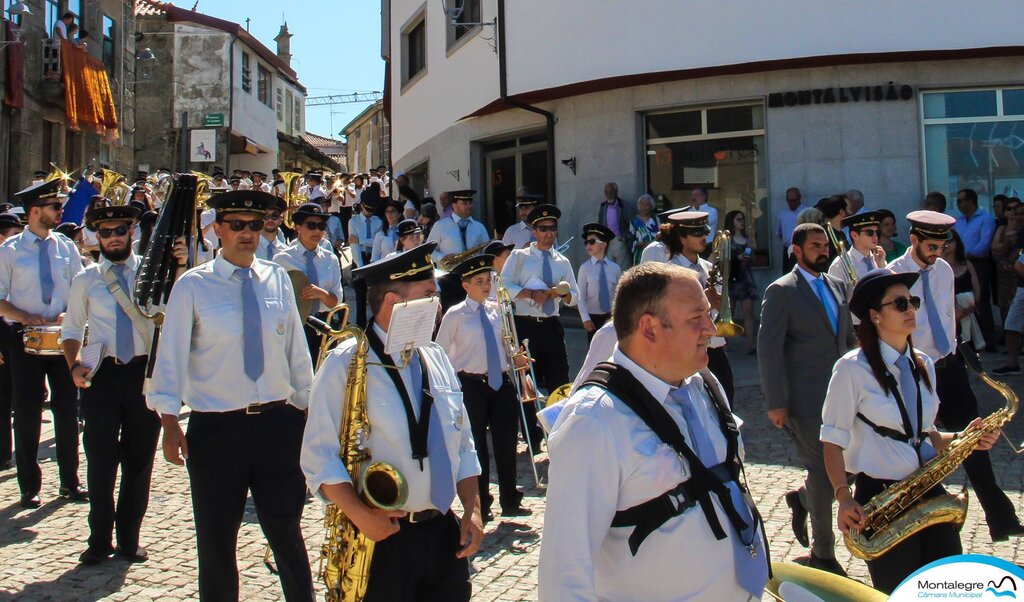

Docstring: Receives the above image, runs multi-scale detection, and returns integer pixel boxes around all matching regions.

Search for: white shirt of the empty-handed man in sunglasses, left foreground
[146,256,313,416]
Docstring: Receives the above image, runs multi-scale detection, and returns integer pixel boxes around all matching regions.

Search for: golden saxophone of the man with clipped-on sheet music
[317,326,409,602]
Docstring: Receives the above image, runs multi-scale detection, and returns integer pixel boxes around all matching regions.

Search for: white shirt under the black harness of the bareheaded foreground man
[539,346,750,602]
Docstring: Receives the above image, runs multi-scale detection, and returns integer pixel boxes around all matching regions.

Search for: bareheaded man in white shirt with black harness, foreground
[539,264,768,601]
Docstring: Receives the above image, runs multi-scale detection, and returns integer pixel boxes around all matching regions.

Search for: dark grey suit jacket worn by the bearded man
[758,267,857,421]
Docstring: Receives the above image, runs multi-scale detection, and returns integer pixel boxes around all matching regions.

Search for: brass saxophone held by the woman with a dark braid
[844,347,1020,560]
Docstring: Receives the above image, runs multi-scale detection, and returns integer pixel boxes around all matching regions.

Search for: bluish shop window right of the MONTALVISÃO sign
[921,88,1024,212]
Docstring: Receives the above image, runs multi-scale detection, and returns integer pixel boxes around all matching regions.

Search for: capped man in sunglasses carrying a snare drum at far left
[0,180,88,508]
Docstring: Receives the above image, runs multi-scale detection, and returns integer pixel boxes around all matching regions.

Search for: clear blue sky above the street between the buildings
[189,0,384,137]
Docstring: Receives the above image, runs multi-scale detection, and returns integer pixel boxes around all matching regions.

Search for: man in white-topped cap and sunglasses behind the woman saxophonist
[889,210,1024,542]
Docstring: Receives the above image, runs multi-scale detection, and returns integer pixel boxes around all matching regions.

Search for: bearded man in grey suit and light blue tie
[758,223,856,574]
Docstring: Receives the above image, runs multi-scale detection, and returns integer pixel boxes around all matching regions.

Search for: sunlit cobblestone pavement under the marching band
[0,329,1024,602]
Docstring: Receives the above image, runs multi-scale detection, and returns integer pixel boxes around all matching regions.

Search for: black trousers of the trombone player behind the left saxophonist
[459,373,522,514]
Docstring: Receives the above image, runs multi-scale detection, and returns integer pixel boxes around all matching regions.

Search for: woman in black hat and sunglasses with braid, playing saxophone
[820,268,999,594]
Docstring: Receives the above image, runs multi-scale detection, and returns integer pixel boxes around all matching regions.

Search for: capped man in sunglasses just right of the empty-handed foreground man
[273,203,344,358]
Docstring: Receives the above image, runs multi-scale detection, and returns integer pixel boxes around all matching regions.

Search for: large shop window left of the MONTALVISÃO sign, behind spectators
[643,103,771,266]
